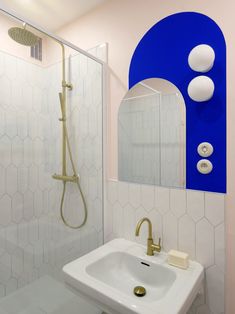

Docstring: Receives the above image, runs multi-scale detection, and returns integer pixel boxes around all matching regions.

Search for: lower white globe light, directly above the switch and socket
[188,75,215,102]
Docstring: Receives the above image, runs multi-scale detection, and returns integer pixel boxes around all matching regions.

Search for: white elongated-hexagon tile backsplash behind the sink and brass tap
[105,180,225,314]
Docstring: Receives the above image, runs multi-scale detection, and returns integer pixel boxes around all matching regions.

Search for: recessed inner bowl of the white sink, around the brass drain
[86,252,176,302]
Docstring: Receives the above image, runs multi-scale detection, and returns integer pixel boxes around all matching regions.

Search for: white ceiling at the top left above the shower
[0,0,107,31]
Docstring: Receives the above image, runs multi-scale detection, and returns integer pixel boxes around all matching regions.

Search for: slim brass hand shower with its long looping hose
[59,93,87,229]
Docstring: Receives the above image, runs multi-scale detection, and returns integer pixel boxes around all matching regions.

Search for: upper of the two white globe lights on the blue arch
[188,44,215,73]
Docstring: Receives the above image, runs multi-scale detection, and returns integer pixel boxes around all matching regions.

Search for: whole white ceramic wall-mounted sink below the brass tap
[63,239,203,314]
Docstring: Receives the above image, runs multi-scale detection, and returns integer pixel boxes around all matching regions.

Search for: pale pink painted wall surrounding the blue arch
[55,0,235,314]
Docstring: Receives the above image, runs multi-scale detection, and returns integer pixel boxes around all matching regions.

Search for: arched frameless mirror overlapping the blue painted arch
[118,78,186,188]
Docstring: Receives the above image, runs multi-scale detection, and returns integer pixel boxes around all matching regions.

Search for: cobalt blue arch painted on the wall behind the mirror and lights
[129,12,226,193]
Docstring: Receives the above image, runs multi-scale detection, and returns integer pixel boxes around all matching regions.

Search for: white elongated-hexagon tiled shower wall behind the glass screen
[0,52,102,297]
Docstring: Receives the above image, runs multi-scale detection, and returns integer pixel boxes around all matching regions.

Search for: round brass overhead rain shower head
[8,23,39,46]
